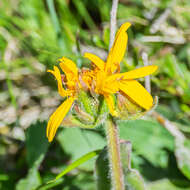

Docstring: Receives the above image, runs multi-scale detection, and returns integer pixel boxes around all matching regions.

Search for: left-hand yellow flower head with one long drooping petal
[46,57,80,142]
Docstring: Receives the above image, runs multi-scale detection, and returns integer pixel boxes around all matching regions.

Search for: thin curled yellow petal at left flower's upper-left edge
[47,66,67,97]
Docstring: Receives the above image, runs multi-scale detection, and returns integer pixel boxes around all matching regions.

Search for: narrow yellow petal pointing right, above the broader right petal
[109,65,158,81]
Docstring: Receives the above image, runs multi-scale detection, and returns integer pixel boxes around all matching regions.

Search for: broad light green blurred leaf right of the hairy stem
[118,120,174,167]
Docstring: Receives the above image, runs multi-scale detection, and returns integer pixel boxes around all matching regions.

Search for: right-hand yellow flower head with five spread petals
[84,22,157,116]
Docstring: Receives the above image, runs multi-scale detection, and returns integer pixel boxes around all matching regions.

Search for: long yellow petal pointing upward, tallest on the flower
[106,22,131,73]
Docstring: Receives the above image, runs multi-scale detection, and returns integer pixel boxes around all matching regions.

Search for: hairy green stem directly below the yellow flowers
[105,118,125,190]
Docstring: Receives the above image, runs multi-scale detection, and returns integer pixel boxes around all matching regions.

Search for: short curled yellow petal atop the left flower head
[59,57,78,80]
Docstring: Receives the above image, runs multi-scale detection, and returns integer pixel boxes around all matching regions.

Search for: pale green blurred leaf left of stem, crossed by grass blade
[58,128,106,170]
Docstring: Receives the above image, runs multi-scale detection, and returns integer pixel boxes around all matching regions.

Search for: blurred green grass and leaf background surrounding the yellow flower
[0,0,190,190]
